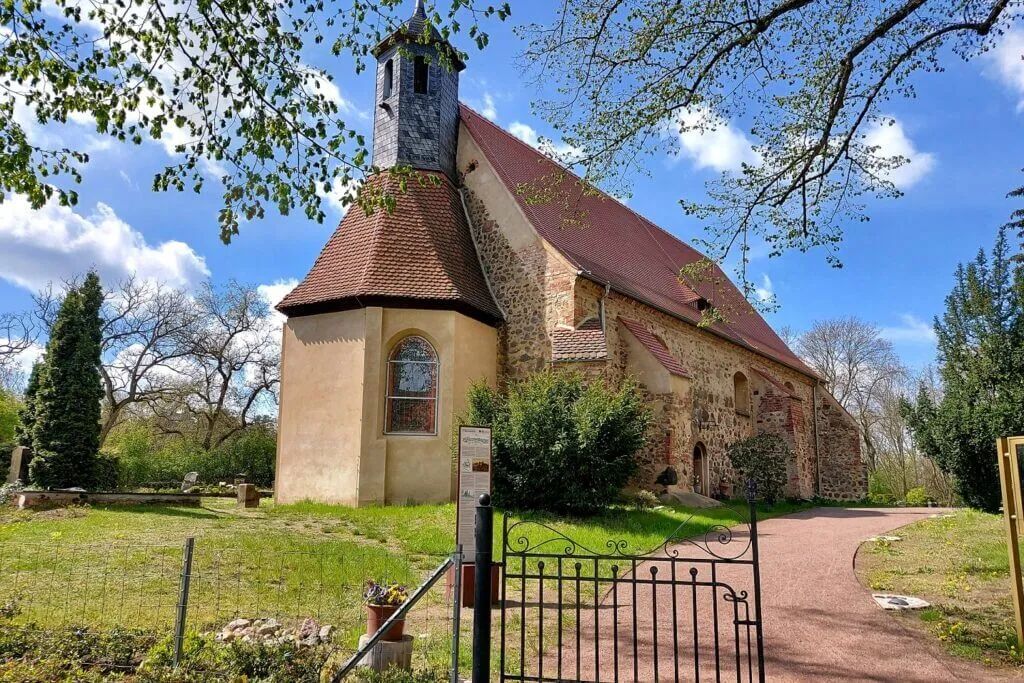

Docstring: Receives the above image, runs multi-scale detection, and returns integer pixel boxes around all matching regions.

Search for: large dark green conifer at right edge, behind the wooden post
[903,226,1024,512]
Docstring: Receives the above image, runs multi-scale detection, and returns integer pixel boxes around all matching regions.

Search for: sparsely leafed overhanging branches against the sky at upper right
[523,0,1018,281]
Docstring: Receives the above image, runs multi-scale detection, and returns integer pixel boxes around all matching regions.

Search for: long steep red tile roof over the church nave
[461,104,817,377]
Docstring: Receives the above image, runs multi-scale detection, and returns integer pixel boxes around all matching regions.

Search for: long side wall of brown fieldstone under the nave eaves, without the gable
[573,278,866,500]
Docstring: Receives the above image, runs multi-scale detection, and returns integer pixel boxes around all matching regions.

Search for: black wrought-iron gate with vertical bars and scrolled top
[500,489,765,682]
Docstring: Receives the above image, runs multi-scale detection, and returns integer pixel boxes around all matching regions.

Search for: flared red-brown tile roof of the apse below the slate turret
[278,173,502,324]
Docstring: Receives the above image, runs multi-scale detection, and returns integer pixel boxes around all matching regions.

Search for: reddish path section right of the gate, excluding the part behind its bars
[759,508,1010,683]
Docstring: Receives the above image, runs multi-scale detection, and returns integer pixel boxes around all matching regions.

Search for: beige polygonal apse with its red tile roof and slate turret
[274,0,502,505]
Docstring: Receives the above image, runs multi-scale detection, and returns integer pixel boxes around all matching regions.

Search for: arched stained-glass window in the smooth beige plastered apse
[385,336,437,434]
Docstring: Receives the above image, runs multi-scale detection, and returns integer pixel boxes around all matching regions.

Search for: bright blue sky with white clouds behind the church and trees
[0,3,1024,374]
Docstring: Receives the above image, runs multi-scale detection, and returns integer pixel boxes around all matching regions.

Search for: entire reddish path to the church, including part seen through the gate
[544,508,1012,683]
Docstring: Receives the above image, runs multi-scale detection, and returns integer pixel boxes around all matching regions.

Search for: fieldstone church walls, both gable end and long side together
[460,145,867,500]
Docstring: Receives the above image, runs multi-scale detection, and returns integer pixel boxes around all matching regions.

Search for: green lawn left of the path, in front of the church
[0,499,808,675]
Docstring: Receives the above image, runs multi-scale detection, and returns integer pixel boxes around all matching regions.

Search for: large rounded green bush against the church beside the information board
[462,372,650,515]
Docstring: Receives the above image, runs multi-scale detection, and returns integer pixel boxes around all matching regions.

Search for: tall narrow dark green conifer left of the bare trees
[29,272,103,488]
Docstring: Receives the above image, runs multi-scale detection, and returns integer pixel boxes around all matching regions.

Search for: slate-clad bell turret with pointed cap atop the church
[373,0,465,181]
